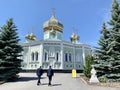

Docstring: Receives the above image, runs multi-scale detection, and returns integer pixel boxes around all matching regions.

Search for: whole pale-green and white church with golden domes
[20,10,92,70]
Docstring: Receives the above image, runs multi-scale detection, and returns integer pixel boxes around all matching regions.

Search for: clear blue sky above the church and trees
[0,0,115,46]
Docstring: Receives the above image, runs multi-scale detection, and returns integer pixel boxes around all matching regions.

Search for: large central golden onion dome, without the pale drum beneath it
[43,10,63,32]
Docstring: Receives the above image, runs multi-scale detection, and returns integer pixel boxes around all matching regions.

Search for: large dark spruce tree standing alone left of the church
[0,19,22,81]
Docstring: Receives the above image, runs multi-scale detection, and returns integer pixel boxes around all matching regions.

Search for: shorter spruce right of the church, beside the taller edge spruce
[95,23,110,77]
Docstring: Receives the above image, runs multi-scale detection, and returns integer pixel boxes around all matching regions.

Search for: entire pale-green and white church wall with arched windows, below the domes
[22,41,91,70]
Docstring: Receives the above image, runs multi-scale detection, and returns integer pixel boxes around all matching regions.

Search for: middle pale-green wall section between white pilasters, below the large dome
[43,43,61,69]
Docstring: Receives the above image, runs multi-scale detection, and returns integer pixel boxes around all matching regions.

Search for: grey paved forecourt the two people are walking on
[0,73,120,90]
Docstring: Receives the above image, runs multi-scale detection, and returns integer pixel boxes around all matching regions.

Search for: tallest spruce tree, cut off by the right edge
[106,0,120,81]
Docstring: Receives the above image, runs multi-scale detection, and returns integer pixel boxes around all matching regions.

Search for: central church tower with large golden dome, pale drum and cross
[43,9,63,40]
